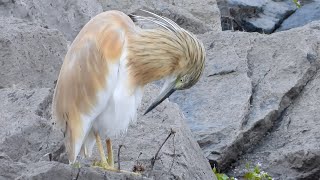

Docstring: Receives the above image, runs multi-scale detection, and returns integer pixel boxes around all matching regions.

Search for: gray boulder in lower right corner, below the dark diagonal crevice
[230,65,320,179]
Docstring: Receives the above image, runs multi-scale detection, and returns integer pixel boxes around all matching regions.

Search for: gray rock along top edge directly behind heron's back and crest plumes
[100,0,221,34]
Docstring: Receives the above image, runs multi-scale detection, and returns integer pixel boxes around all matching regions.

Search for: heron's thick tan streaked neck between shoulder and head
[127,30,185,86]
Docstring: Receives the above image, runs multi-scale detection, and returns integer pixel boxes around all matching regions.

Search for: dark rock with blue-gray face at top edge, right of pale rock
[218,0,296,34]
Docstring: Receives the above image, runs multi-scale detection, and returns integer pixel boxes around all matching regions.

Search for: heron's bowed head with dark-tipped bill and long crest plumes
[131,11,205,114]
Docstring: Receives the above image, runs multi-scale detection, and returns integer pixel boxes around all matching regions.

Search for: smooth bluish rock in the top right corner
[277,1,320,31]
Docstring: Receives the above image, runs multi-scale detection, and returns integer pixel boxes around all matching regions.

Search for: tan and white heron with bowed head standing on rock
[52,10,206,170]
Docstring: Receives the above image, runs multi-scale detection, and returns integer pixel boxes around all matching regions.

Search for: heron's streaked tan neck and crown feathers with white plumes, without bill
[128,10,205,87]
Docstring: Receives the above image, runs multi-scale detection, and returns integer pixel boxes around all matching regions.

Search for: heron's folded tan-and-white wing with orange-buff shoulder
[53,11,129,161]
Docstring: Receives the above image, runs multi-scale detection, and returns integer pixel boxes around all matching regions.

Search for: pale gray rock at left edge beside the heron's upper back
[0,16,67,88]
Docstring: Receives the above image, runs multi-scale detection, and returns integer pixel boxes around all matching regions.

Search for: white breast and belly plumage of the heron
[75,48,143,159]
